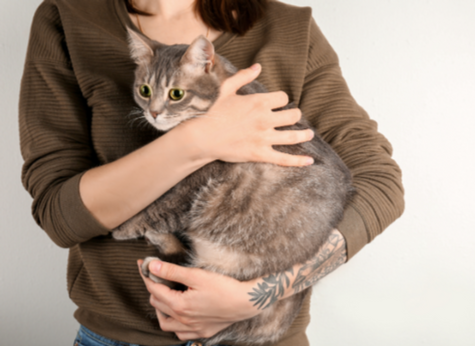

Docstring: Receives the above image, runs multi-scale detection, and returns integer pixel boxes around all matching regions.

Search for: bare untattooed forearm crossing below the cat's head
[79,127,210,229]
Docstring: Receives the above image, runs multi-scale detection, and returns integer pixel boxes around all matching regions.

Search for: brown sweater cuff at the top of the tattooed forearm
[338,205,369,261]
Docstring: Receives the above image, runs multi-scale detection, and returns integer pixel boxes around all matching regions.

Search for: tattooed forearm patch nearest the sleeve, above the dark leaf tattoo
[292,231,347,293]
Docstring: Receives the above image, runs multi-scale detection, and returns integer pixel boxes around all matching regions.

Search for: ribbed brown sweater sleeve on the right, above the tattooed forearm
[299,18,404,259]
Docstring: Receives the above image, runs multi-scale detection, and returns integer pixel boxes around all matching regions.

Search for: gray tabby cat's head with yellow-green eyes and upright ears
[128,29,231,131]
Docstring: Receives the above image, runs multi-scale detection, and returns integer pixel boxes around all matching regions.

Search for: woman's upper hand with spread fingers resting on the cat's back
[175,64,314,166]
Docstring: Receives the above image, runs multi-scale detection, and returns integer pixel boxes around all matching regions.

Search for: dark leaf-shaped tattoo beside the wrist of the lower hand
[248,268,294,309]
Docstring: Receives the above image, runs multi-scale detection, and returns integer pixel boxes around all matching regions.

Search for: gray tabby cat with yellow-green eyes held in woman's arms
[113,30,353,345]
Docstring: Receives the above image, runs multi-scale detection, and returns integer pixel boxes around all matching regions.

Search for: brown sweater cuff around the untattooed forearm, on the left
[59,172,110,243]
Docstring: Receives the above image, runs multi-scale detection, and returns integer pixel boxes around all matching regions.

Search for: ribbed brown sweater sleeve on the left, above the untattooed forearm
[19,2,108,247]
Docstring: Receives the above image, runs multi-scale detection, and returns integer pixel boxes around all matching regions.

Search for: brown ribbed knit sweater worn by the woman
[20,0,404,345]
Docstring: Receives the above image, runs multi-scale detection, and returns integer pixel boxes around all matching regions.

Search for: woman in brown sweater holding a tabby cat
[20,0,403,345]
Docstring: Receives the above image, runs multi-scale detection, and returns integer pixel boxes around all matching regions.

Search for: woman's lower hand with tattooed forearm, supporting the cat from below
[138,229,347,340]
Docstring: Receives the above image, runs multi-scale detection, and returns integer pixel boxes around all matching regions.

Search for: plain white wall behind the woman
[0,0,475,345]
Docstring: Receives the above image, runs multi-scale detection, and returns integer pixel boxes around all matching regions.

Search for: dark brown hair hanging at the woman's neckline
[124,0,268,35]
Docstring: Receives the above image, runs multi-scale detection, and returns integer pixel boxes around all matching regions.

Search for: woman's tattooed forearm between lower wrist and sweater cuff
[248,229,347,309]
